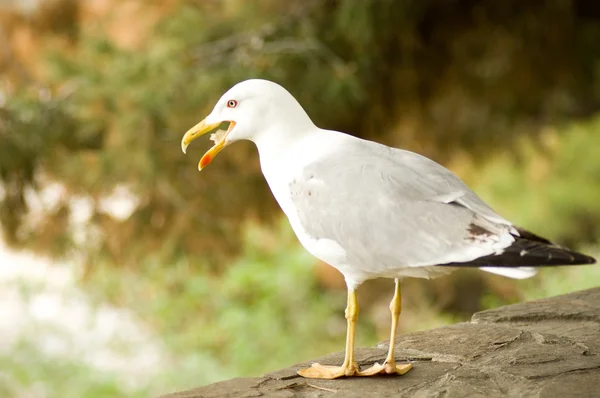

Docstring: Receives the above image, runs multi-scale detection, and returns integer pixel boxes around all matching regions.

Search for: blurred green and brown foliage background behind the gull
[0,0,600,398]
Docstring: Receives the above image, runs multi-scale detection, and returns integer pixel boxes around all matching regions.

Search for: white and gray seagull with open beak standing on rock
[181,79,595,379]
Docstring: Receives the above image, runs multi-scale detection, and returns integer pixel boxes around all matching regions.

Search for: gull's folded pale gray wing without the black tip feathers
[290,140,512,271]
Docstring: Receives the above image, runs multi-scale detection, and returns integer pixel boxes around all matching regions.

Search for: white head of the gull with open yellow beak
[181,79,312,170]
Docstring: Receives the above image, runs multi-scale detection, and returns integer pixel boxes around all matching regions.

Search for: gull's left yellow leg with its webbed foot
[298,289,358,379]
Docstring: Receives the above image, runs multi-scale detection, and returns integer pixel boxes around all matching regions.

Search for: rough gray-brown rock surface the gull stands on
[163,288,600,398]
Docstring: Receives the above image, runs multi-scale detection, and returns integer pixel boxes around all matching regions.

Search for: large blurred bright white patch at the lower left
[0,242,165,388]
